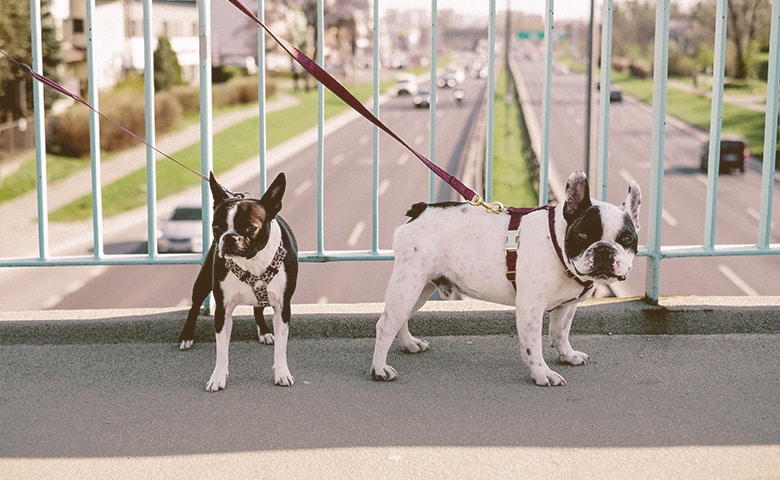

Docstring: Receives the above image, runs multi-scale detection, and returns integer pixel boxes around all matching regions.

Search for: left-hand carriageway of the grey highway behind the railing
[35,75,486,309]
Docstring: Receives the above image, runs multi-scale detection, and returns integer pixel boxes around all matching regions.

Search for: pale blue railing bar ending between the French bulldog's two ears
[595,0,612,201]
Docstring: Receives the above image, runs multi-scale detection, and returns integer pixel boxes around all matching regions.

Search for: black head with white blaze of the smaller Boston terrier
[209,174,286,258]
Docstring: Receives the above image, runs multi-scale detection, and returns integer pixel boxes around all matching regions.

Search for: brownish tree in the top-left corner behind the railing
[0,0,61,121]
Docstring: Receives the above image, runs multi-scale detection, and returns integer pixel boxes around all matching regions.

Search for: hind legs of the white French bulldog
[371,276,435,382]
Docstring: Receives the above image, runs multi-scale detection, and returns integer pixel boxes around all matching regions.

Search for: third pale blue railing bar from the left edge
[143,0,157,258]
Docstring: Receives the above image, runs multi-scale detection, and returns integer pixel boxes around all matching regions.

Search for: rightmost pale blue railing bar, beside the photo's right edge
[757,0,780,247]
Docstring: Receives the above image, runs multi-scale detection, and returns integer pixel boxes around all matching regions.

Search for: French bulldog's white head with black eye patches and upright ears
[564,172,641,284]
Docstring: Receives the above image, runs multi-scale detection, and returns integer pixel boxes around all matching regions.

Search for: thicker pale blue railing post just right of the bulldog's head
[645,0,669,303]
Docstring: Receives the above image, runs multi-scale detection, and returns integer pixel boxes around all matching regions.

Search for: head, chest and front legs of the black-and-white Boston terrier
[206,173,298,392]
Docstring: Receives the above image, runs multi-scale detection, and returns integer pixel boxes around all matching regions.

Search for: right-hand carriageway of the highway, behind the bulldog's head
[514,47,780,296]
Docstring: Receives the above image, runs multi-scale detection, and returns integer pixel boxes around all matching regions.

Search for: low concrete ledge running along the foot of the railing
[0,297,780,345]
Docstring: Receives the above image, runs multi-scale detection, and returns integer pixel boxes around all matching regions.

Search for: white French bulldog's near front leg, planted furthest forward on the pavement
[517,305,566,386]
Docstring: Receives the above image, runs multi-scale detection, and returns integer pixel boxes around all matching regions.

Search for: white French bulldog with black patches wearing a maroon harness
[371,171,641,386]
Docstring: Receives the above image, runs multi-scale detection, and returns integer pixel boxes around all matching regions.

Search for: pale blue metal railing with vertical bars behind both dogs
[0,0,780,301]
